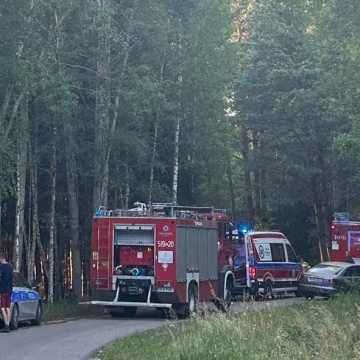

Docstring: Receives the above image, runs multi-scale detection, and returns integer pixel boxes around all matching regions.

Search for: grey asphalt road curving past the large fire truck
[0,298,304,360]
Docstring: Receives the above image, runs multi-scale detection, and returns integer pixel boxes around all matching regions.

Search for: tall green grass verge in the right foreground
[99,294,360,360]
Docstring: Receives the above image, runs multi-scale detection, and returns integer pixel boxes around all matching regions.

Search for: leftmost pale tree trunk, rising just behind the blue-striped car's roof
[13,101,29,272]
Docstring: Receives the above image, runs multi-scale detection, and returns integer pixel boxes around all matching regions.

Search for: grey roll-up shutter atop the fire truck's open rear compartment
[114,225,154,246]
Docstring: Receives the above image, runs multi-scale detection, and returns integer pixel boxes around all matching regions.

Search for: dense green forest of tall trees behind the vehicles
[0,0,360,301]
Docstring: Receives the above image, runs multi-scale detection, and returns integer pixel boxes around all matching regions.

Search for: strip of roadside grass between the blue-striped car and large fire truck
[43,301,97,322]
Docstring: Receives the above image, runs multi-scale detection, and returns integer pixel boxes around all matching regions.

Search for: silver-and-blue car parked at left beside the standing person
[0,273,43,330]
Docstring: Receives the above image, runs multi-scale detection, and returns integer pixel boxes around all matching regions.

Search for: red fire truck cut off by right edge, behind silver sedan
[330,213,360,262]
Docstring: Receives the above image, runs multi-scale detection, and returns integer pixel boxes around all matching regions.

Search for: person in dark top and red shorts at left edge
[0,252,13,332]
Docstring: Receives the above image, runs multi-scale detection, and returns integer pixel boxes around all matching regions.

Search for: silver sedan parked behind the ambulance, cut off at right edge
[299,261,360,298]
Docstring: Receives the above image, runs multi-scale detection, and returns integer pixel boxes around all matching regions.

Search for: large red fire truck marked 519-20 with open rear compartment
[91,203,231,316]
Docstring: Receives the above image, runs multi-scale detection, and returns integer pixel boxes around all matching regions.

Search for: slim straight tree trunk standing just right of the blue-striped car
[48,125,57,303]
